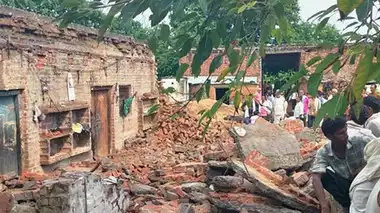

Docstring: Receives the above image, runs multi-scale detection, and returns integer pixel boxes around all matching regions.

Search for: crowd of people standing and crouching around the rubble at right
[242,85,380,213]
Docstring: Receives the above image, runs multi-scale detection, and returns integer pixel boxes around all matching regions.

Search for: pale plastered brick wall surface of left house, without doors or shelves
[0,16,157,171]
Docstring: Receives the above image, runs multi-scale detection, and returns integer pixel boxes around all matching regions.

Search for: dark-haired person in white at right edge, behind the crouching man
[363,96,380,137]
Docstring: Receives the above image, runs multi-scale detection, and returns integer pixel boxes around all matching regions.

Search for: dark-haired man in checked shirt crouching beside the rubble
[310,118,373,213]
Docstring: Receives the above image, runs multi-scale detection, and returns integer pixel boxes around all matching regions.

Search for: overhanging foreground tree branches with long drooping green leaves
[8,0,374,129]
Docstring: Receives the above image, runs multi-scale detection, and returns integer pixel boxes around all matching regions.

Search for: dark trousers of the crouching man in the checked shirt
[322,169,352,208]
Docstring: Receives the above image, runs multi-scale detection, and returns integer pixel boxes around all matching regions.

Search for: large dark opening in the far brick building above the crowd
[261,52,301,92]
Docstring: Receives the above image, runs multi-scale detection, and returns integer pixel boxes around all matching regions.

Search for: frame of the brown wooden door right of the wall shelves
[90,86,112,154]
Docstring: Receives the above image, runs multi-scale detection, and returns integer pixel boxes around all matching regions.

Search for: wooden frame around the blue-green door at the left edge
[0,90,21,174]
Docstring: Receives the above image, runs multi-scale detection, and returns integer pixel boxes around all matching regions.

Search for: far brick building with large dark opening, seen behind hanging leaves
[174,46,356,99]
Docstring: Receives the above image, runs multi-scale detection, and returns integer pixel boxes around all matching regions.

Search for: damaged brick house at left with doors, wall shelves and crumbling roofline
[0,7,158,174]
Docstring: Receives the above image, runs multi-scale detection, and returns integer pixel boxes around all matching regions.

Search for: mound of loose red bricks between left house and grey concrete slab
[66,99,236,184]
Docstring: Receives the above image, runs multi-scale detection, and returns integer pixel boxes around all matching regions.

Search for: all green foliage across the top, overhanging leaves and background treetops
[11,0,380,130]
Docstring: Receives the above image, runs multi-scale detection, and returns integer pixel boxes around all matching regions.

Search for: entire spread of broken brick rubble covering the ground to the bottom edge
[0,98,330,213]
